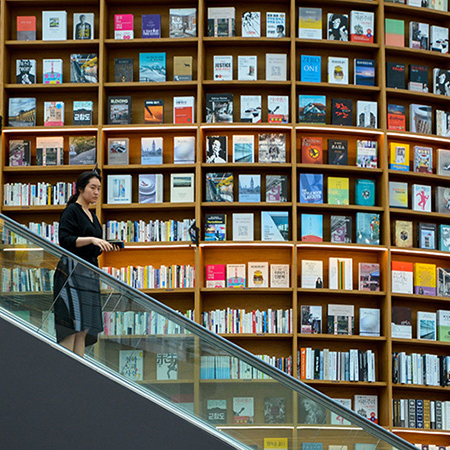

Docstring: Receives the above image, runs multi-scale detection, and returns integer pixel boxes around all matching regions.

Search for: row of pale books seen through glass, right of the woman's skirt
[103,310,194,336]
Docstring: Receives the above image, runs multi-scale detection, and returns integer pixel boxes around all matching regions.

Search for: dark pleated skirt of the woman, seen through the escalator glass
[53,257,103,346]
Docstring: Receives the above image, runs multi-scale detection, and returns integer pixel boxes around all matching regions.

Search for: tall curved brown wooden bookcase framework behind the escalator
[0,0,450,445]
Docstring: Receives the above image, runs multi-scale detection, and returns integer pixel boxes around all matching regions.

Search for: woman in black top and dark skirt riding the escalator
[54,169,116,356]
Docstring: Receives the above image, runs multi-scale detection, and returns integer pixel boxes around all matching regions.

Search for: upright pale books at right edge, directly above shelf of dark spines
[392,352,450,386]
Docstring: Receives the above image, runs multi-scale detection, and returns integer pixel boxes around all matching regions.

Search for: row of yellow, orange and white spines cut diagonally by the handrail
[102,264,195,289]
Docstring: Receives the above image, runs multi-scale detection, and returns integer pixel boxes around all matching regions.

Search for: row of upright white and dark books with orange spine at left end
[298,347,376,382]
